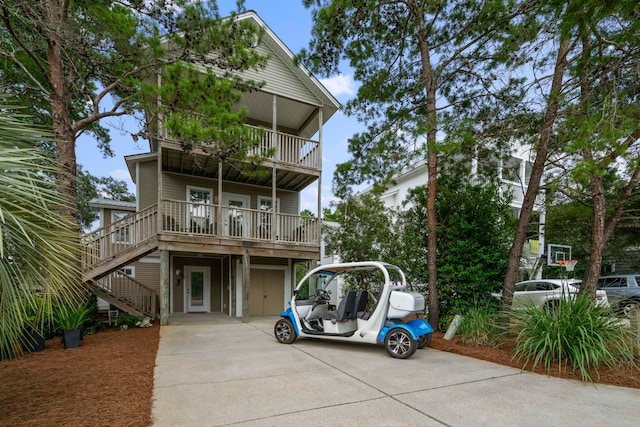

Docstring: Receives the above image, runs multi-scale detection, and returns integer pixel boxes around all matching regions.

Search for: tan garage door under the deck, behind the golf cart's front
[249,269,284,316]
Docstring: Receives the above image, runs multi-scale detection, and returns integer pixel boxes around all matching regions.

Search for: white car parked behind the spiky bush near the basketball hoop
[513,279,609,307]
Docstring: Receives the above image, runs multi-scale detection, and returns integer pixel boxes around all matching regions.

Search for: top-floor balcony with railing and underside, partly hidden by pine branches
[159,125,322,191]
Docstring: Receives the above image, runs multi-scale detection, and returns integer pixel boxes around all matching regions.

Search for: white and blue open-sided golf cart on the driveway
[274,261,433,359]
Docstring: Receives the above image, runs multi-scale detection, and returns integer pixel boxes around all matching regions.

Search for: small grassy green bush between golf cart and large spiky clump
[457,306,500,347]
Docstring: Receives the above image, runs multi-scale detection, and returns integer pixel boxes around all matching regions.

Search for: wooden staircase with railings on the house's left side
[81,205,158,319]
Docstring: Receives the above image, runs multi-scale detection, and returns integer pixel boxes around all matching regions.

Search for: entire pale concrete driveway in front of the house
[152,316,640,427]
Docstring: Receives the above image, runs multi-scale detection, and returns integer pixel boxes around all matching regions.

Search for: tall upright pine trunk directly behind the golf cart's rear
[416,10,440,329]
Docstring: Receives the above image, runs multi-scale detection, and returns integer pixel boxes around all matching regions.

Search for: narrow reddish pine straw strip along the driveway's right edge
[429,332,640,388]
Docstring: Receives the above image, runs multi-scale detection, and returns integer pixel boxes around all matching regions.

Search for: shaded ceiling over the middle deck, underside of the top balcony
[162,148,319,191]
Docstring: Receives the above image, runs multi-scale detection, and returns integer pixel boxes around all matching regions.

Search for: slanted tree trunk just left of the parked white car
[502,39,569,310]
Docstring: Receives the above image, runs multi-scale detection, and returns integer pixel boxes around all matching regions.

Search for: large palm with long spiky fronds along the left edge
[0,95,80,354]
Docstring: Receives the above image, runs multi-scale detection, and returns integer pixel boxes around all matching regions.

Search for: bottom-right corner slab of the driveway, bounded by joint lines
[401,373,640,426]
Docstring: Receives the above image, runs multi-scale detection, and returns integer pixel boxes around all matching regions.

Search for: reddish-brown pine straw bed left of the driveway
[0,324,160,427]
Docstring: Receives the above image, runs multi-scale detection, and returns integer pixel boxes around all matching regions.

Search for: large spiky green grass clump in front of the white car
[510,294,636,381]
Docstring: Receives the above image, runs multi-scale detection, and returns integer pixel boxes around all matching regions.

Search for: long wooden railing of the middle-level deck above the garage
[162,200,320,245]
